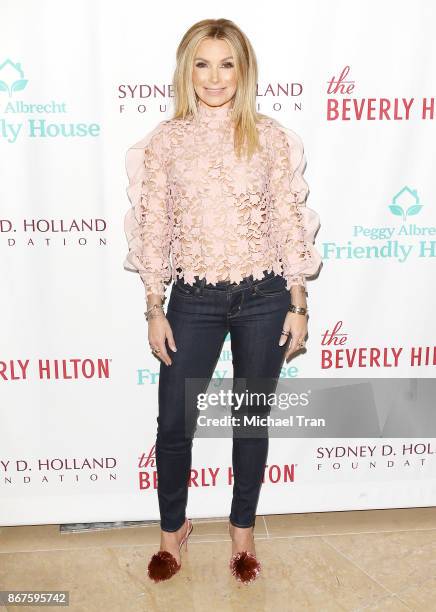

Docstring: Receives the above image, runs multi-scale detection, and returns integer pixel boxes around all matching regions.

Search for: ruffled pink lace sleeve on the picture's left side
[123,122,171,297]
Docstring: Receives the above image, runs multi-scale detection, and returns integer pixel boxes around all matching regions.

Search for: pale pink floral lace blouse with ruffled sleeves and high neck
[124,105,321,296]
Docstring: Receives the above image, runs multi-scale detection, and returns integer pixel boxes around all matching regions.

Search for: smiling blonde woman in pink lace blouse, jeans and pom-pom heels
[124,19,321,583]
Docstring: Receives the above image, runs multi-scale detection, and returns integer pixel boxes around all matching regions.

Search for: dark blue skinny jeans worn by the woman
[156,271,291,531]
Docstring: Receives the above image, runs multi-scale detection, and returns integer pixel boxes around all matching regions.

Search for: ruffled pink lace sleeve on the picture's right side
[270,121,322,289]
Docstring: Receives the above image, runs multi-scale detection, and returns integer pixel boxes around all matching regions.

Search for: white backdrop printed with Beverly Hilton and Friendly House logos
[0,0,436,525]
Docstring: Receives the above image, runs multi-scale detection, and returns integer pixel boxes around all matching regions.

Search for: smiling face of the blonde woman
[192,38,236,107]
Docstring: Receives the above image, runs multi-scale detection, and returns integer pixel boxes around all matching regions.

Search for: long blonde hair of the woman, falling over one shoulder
[173,19,265,159]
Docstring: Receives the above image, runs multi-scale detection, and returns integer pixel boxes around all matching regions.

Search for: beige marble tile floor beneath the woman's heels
[0,507,436,612]
